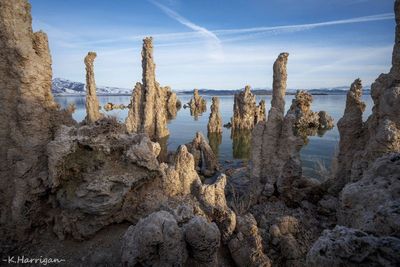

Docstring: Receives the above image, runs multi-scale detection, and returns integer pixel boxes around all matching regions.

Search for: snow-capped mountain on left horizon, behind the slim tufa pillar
[52,78,132,96]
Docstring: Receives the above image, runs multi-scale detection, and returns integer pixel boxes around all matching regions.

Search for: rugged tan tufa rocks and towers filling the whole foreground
[0,0,400,266]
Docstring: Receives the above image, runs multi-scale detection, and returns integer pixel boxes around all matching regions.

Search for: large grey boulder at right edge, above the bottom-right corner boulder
[337,153,400,238]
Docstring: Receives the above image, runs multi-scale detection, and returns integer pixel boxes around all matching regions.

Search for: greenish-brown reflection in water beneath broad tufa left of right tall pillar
[231,130,251,160]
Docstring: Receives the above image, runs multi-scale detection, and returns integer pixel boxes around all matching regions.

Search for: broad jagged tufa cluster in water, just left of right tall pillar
[231,85,266,131]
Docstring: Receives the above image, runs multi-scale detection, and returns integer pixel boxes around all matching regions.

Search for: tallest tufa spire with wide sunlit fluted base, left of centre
[125,37,180,140]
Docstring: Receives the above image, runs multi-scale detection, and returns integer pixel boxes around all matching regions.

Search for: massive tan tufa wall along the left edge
[0,0,74,239]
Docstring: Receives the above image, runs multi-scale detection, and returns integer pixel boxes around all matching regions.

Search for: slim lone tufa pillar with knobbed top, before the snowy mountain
[85,52,101,123]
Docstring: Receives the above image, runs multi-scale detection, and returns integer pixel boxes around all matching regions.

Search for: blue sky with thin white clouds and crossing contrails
[30,0,395,90]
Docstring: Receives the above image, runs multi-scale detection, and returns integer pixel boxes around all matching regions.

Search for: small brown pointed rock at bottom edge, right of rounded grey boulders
[228,214,271,267]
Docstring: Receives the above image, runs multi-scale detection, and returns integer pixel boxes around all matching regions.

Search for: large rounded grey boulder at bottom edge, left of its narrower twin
[121,211,187,266]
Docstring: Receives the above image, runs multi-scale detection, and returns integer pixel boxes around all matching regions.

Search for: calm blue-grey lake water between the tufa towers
[55,95,373,178]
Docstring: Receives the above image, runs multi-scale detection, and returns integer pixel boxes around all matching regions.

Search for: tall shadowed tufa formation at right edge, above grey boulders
[331,1,400,193]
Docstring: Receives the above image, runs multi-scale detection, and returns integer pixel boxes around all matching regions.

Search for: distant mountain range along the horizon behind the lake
[52,78,370,96]
